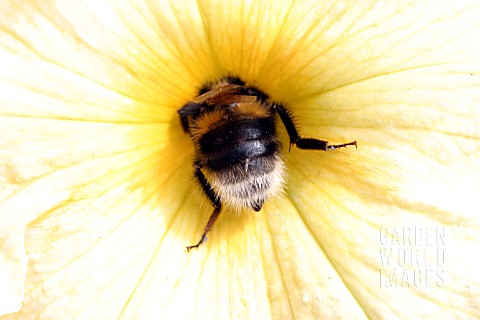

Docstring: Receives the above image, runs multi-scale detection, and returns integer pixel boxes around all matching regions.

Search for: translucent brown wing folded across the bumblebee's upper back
[193,84,257,105]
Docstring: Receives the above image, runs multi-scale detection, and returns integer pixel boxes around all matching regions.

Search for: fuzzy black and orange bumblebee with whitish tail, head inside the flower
[178,77,357,251]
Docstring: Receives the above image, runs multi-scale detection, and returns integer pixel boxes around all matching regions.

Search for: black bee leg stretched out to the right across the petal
[273,104,357,152]
